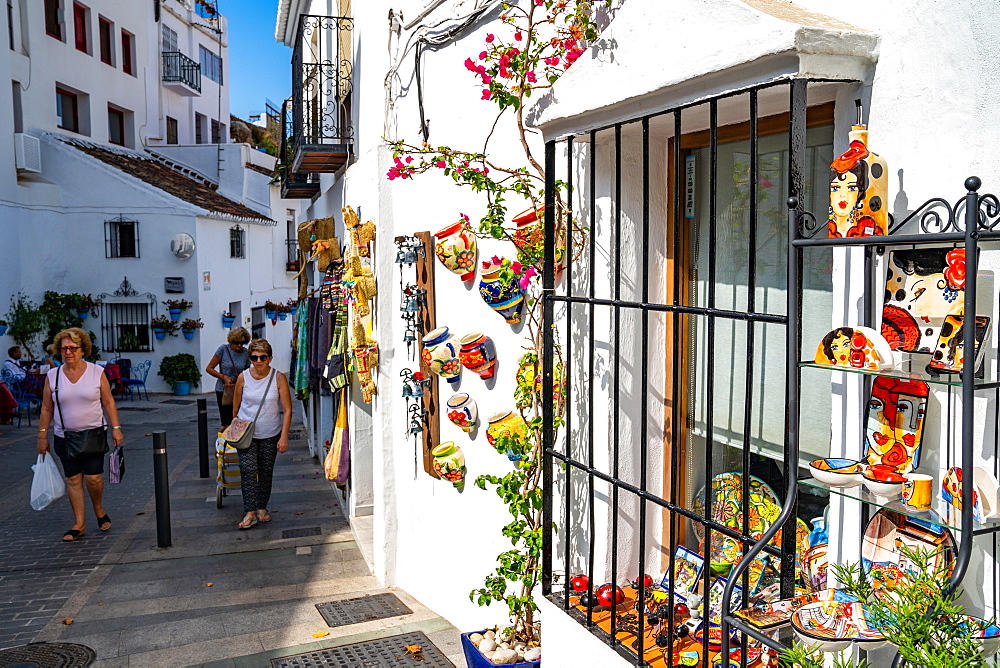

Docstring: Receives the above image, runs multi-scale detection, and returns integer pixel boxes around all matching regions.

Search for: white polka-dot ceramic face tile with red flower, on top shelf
[882,248,965,353]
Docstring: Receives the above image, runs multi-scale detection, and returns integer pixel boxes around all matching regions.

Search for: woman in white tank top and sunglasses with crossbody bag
[233,339,292,529]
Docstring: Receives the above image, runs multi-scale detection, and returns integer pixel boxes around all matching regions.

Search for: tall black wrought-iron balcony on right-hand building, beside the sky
[291,14,354,174]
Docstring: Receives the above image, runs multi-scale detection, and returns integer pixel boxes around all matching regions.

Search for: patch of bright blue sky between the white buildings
[225,0,292,119]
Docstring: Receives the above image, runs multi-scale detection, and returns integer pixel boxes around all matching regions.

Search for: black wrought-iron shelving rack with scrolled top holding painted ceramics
[720,179,1000,663]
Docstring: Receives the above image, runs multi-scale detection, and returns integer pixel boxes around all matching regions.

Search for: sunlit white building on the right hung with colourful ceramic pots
[276,0,1000,666]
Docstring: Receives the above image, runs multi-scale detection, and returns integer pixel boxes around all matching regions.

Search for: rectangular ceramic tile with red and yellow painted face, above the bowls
[865,376,928,475]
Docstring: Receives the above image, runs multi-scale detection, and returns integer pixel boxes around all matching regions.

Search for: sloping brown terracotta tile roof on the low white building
[64,138,276,225]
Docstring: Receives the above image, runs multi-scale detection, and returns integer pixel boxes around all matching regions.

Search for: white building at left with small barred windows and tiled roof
[0,0,297,391]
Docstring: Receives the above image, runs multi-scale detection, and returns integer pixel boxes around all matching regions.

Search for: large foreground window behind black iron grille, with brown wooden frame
[541,80,842,665]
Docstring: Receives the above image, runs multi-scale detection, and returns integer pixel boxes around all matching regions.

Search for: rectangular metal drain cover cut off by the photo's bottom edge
[271,631,455,668]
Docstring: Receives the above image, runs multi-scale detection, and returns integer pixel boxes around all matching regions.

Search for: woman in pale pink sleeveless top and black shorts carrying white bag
[36,327,124,542]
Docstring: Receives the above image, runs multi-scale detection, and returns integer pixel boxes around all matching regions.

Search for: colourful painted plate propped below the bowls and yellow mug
[861,508,955,589]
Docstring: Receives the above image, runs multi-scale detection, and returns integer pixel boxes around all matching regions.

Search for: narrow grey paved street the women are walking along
[0,395,465,667]
